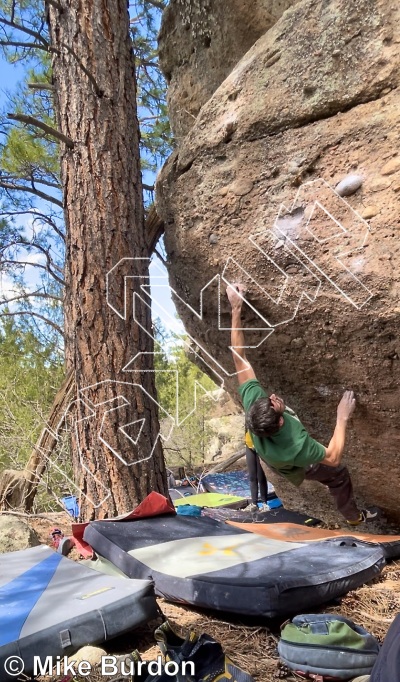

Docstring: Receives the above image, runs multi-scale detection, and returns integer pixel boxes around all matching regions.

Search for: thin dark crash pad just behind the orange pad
[201,507,321,524]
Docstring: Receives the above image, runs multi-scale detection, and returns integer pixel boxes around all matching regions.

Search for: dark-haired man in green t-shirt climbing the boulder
[226,284,378,526]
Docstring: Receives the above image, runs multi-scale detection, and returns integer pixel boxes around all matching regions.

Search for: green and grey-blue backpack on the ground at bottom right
[278,613,379,680]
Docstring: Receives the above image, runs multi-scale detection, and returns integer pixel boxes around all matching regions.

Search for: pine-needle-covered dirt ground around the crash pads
[24,513,400,682]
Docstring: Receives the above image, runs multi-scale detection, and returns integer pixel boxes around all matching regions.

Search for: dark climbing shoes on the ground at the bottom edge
[154,622,254,682]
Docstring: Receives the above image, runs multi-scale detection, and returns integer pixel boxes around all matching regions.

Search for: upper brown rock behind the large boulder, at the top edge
[159,0,296,140]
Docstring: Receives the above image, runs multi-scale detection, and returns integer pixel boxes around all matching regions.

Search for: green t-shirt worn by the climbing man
[239,379,325,485]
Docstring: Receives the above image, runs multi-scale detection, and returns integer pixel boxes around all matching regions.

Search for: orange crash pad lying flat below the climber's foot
[227,520,400,559]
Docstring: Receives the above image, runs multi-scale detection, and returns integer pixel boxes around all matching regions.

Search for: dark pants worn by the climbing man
[305,464,360,521]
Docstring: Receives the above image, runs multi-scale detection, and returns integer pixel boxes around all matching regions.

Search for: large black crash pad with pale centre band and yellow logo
[84,514,385,617]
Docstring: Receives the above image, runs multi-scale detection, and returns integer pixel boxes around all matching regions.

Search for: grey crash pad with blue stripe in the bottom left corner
[0,545,157,682]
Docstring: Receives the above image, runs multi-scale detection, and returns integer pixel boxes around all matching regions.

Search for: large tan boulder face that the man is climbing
[157,0,400,520]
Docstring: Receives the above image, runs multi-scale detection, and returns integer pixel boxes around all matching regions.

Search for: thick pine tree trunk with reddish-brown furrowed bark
[48,0,167,519]
